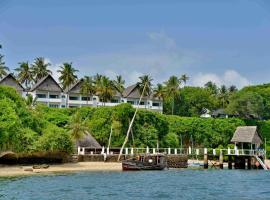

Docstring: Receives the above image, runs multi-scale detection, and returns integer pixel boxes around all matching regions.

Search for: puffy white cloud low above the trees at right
[191,70,250,88]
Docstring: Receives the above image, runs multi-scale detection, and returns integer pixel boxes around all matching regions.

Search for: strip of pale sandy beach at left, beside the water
[0,162,122,177]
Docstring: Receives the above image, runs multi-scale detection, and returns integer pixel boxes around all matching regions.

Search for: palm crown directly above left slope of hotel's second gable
[32,57,52,82]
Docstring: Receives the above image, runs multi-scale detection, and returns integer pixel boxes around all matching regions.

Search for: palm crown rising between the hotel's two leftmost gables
[15,62,33,89]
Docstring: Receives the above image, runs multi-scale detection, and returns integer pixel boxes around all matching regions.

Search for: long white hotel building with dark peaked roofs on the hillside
[0,74,163,112]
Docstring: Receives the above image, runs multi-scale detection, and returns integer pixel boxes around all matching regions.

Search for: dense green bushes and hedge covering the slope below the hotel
[0,86,270,156]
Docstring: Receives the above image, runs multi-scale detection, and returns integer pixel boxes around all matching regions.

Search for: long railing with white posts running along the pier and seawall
[78,147,265,156]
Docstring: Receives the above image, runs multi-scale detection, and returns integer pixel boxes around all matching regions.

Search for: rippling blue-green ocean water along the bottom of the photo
[0,169,270,200]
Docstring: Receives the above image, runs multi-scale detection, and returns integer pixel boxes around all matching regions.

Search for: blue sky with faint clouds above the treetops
[0,0,270,88]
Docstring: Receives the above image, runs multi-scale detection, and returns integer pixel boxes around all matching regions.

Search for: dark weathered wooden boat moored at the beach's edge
[122,154,167,171]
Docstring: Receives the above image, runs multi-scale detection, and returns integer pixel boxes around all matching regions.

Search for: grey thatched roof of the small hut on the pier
[231,126,262,144]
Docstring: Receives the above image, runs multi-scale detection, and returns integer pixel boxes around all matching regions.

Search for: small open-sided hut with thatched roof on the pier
[231,126,263,149]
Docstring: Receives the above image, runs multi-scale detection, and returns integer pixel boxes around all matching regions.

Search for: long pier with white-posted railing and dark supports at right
[78,147,267,169]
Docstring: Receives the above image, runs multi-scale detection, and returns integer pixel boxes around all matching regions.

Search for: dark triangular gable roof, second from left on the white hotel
[30,74,63,92]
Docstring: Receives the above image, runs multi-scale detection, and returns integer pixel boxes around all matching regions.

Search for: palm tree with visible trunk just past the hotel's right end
[165,76,181,115]
